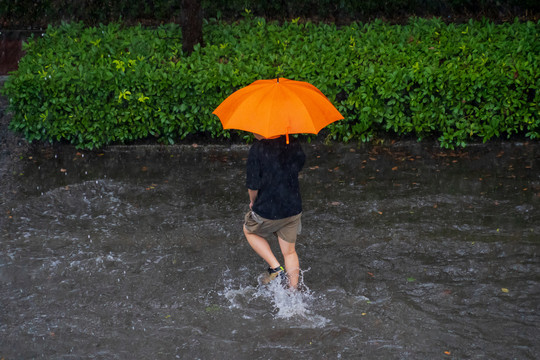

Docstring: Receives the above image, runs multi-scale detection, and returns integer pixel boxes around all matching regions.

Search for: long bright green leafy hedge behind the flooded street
[3,14,540,148]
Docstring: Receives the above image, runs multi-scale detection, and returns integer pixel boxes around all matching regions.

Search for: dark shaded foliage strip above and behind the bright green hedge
[0,0,540,29]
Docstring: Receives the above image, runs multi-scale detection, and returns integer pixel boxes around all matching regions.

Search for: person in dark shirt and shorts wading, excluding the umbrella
[244,134,306,289]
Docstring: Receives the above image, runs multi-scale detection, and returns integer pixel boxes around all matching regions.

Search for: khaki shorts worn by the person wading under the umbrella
[244,210,302,243]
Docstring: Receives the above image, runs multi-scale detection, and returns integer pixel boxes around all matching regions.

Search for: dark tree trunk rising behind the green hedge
[184,0,203,54]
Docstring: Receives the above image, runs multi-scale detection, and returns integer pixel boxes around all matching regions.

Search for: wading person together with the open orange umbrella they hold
[212,77,343,288]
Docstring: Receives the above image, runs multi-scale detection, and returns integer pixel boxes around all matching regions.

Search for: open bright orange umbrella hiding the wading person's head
[213,78,343,141]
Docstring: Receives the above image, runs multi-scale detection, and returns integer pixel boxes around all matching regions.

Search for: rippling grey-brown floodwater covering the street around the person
[0,143,540,359]
